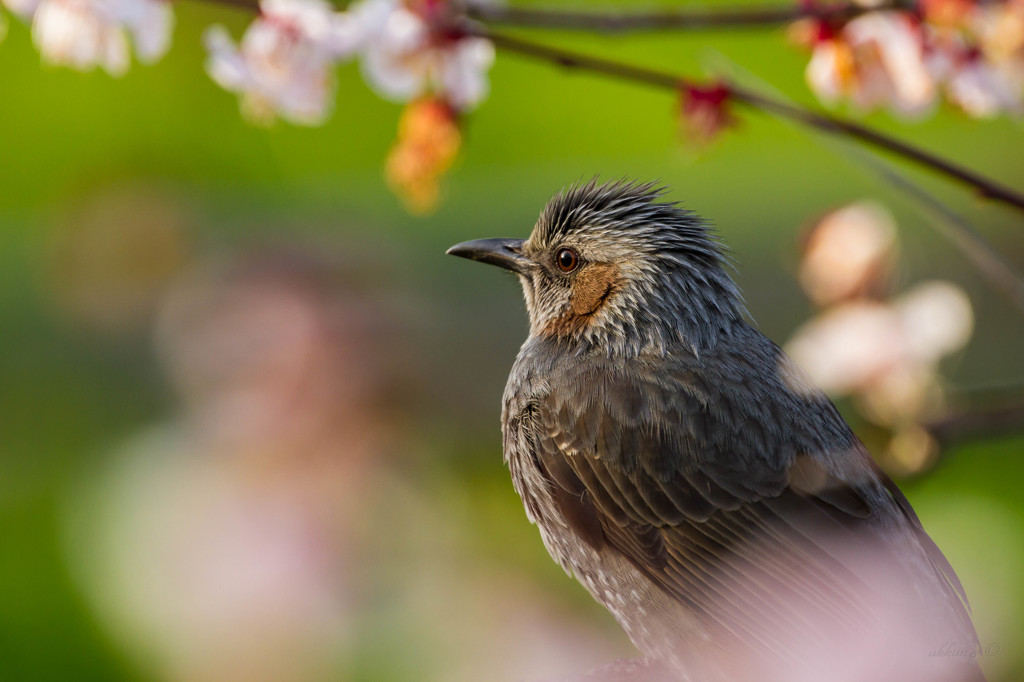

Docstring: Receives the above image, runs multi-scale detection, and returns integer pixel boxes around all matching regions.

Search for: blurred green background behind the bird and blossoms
[0,2,1024,680]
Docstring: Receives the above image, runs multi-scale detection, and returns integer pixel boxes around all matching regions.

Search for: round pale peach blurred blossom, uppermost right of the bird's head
[799,202,896,305]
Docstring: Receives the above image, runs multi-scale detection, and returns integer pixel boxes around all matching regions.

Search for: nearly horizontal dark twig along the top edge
[466,0,913,33]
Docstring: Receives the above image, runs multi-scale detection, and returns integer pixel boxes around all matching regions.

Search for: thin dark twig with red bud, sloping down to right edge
[473,26,1024,211]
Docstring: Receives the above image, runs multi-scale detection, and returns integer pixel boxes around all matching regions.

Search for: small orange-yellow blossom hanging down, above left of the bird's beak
[386,98,462,213]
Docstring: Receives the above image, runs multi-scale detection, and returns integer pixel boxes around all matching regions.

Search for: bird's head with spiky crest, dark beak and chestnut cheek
[447,180,742,353]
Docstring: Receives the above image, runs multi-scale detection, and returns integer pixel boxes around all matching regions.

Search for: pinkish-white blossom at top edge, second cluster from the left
[204,0,358,125]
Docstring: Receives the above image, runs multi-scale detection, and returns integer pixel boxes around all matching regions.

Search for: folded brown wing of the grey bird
[530,356,969,649]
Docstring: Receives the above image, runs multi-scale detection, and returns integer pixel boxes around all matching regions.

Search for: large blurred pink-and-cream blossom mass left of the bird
[69,248,629,682]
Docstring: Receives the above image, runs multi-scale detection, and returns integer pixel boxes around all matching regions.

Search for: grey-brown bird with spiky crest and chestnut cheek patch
[447,178,984,681]
